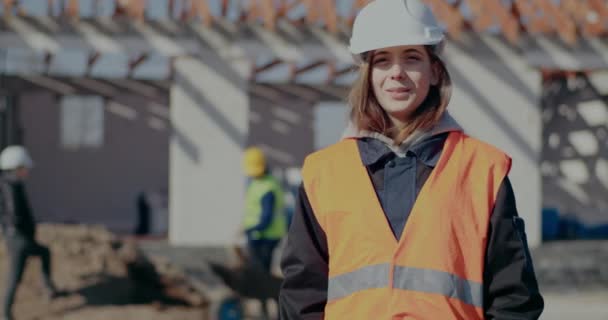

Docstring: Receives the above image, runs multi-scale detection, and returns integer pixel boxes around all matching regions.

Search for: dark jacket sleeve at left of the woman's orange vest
[279,186,328,320]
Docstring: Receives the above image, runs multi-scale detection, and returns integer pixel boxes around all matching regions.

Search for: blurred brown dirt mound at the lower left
[0,225,207,320]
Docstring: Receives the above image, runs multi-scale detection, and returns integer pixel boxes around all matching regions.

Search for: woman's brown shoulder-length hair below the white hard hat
[348,46,452,144]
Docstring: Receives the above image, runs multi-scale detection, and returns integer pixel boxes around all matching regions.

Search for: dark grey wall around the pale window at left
[19,87,170,232]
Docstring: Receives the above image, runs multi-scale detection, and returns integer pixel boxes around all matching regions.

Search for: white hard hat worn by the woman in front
[349,0,444,56]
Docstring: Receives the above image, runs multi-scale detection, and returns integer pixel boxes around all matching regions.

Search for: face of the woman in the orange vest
[370,46,438,125]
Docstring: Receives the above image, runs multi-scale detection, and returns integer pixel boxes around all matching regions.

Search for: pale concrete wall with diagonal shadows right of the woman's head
[445,39,542,247]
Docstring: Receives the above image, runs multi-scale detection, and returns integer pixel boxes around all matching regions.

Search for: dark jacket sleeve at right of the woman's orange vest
[484,178,544,320]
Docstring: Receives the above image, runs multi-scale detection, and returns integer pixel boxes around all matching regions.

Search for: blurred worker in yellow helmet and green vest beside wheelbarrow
[243,147,287,272]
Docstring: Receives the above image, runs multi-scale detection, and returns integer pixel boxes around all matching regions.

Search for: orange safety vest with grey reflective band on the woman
[302,132,511,320]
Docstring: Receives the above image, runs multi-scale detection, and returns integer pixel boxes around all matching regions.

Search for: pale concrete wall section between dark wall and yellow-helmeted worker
[169,54,250,245]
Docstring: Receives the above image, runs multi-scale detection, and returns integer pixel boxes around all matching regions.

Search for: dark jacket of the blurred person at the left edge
[0,174,36,239]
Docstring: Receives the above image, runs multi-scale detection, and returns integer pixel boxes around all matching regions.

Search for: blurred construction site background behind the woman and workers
[0,0,608,320]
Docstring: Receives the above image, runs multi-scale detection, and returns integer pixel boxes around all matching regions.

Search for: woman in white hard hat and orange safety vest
[280,0,543,319]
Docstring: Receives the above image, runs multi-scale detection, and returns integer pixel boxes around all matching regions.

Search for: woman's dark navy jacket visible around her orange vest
[279,129,544,320]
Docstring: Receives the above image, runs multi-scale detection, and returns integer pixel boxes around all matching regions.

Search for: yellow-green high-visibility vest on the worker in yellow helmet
[243,175,287,240]
